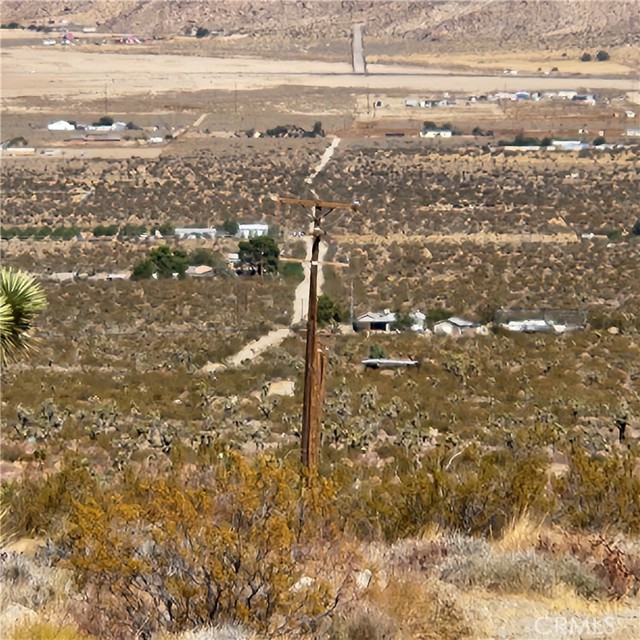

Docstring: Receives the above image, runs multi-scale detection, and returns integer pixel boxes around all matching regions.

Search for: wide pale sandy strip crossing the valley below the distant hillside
[1,47,638,106]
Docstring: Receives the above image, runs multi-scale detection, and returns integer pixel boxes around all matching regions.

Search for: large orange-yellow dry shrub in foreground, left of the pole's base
[59,454,344,638]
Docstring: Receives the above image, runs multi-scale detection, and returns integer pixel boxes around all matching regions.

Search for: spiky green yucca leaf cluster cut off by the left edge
[0,267,47,364]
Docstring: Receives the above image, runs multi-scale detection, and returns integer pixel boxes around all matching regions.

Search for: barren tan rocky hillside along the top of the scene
[2,0,640,50]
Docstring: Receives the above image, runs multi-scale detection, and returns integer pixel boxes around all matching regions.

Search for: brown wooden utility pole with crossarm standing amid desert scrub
[278,198,358,475]
